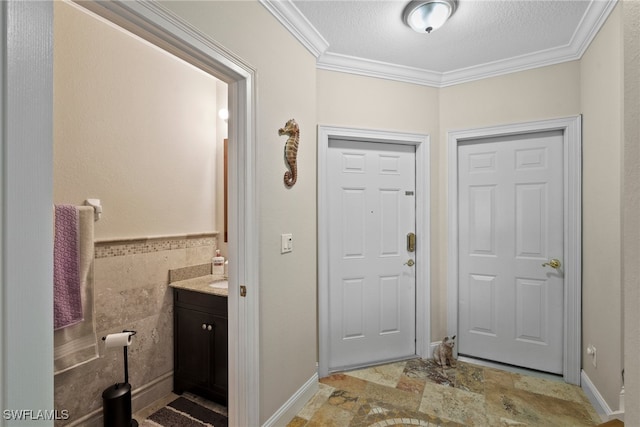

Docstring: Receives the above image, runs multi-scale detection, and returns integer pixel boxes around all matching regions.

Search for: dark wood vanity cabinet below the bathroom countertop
[173,289,228,406]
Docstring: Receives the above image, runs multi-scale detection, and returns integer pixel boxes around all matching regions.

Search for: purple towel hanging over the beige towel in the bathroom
[53,205,82,329]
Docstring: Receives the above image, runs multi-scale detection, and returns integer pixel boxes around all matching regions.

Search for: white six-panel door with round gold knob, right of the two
[458,131,564,373]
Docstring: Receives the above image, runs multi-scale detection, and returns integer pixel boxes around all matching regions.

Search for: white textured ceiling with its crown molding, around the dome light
[262,0,615,86]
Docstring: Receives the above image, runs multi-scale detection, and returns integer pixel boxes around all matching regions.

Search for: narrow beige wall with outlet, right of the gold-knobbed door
[580,5,623,410]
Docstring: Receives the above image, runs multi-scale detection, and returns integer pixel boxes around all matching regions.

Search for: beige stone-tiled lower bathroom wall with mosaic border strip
[54,235,217,426]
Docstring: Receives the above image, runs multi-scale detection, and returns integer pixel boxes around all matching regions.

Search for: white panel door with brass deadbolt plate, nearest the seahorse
[327,140,419,371]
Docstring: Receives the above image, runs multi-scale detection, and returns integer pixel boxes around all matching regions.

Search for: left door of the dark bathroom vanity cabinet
[174,307,212,394]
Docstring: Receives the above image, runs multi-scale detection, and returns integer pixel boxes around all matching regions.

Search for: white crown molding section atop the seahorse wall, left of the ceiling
[259,0,329,58]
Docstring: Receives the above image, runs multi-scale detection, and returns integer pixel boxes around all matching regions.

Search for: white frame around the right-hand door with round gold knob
[447,116,582,385]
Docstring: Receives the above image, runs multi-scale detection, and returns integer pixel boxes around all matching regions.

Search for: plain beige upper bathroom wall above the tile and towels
[54,2,225,240]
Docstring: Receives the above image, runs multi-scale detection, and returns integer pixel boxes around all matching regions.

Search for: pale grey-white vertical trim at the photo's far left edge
[0,0,54,418]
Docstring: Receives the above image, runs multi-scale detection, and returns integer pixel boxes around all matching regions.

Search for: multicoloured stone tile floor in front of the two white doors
[287,359,601,427]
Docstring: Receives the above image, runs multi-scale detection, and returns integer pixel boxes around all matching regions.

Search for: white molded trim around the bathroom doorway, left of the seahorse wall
[68,0,260,425]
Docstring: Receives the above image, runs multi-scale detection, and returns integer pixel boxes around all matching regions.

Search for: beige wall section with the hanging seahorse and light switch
[157,1,317,422]
